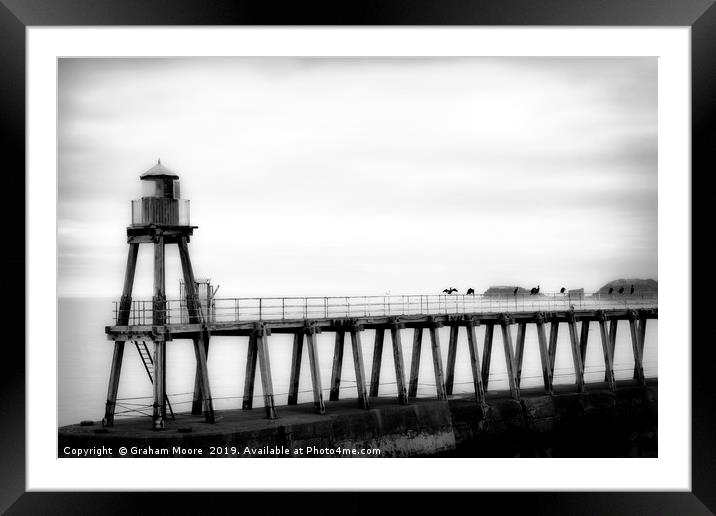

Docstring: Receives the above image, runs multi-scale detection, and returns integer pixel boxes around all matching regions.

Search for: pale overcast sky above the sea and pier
[57,58,658,297]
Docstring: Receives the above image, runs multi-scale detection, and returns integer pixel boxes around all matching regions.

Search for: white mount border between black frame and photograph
[26,27,691,491]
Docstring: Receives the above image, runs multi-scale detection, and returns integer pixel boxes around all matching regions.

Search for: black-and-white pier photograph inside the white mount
[58,56,659,459]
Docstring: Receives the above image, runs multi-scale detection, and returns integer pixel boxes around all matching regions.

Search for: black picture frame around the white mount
[5,0,716,514]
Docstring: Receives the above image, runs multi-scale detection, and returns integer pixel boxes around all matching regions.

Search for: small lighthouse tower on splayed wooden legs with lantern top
[102,160,214,430]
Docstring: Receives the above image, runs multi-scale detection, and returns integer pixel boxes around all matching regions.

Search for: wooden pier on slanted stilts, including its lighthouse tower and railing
[98,164,658,430]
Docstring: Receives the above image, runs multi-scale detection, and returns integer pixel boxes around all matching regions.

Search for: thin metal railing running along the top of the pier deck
[114,292,658,326]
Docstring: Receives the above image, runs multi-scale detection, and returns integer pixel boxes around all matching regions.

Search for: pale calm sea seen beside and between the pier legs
[58,298,658,426]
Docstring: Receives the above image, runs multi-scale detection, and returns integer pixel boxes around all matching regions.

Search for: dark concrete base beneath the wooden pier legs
[58,379,658,458]
